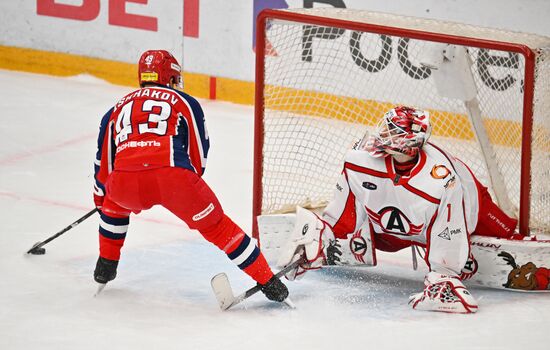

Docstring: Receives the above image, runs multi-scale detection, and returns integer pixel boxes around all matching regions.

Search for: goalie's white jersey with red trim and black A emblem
[323,144,479,275]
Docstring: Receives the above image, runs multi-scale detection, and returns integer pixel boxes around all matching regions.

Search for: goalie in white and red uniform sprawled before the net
[278,106,517,313]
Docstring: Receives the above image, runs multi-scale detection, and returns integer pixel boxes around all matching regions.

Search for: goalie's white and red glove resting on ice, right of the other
[409,272,477,314]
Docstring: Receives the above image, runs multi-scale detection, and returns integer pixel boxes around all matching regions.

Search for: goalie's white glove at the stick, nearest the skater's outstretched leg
[277,207,334,281]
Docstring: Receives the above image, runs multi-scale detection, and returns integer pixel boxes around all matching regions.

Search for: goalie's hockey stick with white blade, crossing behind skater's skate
[210,258,303,311]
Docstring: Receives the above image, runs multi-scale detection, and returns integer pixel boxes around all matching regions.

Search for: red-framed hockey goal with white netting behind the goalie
[253,8,550,237]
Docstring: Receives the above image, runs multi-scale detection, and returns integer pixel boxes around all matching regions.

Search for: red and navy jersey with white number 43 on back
[95,86,210,194]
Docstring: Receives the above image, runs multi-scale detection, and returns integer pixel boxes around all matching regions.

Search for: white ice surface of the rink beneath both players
[0,70,550,350]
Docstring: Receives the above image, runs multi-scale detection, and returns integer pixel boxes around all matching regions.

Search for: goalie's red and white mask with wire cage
[364,106,431,157]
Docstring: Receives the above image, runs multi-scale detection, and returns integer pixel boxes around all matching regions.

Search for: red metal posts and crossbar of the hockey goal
[252,9,536,239]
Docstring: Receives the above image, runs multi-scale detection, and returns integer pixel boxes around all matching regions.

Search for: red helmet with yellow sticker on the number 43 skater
[138,50,183,89]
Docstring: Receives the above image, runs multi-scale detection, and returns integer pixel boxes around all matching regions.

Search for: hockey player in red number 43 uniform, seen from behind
[94,50,288,302]
